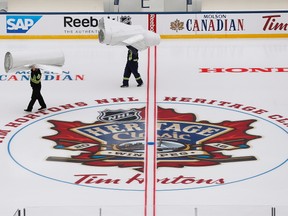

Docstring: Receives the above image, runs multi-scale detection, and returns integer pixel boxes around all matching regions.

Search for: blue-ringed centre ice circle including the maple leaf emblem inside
[9,98,287,191]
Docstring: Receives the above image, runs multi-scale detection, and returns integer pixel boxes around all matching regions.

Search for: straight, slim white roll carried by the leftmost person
[4,50,65,73]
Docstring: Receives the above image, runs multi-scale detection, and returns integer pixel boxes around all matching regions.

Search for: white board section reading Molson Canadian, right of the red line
[157,12,288,37]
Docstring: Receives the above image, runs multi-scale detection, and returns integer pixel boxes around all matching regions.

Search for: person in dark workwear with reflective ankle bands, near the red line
[121,46,143,88]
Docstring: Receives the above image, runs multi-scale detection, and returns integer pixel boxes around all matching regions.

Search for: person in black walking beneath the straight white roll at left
[24,65,46,112]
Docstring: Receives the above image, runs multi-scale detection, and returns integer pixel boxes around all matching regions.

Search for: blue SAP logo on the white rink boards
[6,16,42,33]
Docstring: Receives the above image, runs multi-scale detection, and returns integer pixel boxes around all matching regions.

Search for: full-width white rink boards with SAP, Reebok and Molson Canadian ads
[0,12,288,39]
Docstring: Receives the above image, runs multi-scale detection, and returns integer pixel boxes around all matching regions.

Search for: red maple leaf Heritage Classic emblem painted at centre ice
[44,107,260,172]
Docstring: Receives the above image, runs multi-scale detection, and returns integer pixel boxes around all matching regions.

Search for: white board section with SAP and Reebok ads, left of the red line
[0,14,147,38]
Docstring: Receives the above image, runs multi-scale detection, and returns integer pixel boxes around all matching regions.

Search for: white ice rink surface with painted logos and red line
[0,39,288,216]
